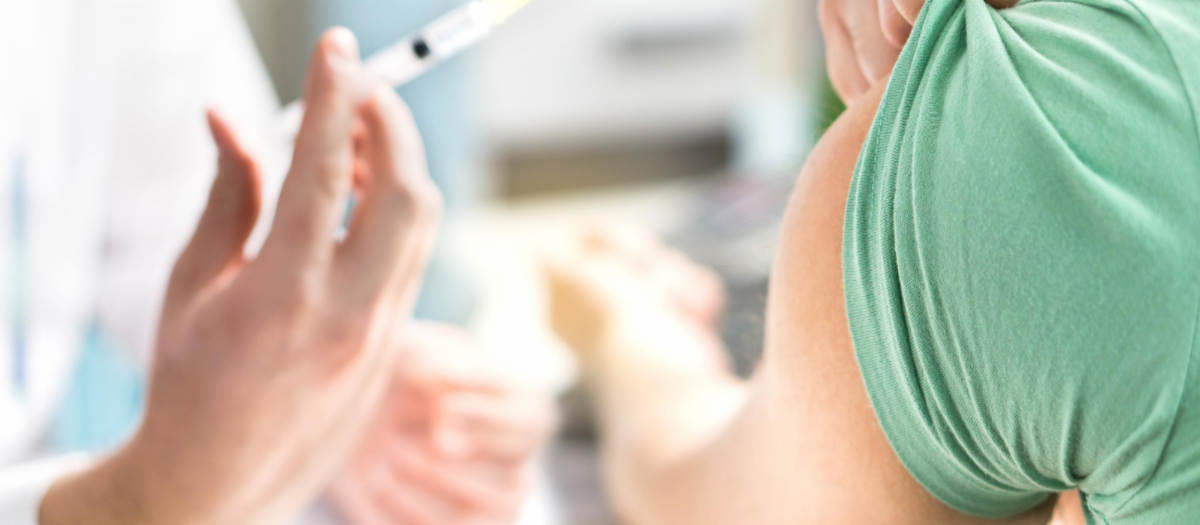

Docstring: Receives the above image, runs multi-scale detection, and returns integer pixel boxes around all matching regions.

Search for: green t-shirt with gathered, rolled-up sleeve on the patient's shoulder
[844,0,1200,525]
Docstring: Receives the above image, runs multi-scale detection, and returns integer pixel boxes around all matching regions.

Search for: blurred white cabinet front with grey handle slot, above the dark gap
[478,0,739,147]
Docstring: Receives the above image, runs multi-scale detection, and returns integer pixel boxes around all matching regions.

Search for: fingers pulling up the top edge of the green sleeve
[820,0,1018,104]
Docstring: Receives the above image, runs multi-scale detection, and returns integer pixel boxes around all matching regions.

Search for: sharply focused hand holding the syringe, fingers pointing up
[41,30,439,525]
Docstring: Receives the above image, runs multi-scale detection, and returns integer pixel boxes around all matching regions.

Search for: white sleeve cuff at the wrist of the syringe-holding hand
[0,454,91,525]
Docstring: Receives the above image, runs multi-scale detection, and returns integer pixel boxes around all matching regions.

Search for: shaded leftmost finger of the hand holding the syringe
[167,110,263,309]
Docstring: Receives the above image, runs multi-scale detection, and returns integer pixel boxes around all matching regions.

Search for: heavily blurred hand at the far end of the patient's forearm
[545,225,728,370]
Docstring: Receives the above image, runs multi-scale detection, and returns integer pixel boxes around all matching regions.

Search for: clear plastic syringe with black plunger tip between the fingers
[280,0,529,137]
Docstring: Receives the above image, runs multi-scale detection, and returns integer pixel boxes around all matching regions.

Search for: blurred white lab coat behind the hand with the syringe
[0,0,282,525]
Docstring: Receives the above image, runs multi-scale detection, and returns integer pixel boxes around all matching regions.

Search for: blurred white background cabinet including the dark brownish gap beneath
[475,0,820,193]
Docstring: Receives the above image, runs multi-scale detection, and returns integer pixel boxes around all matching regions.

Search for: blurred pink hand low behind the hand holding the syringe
[329,325,556,525]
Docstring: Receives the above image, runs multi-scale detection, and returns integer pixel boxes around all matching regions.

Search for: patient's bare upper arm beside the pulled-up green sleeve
[656,85,1051,525]
